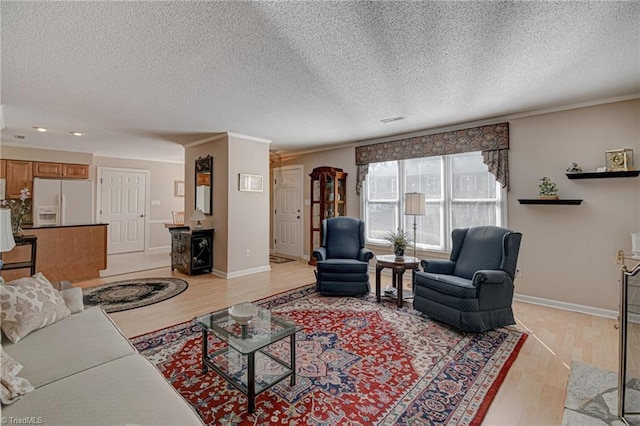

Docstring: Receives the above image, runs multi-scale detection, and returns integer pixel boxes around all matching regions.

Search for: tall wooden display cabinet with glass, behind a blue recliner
[309,167,347,265]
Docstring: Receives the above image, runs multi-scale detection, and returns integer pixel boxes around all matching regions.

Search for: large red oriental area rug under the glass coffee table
[132,286,527,425]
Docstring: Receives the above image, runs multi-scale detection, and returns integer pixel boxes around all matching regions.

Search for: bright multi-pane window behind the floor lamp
[363,152,506,251]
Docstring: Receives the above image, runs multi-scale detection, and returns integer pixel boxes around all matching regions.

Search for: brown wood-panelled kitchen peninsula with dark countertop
[1,223,108,282]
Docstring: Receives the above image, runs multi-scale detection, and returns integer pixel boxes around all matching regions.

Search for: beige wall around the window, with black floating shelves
[272,99,640,311]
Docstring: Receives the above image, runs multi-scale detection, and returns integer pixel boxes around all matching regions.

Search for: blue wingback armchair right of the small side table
[413,226,522,332]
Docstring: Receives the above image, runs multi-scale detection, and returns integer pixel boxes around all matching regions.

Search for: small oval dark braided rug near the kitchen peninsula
[82,278,189,313]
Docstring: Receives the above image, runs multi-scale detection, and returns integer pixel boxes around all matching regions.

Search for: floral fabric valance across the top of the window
[356,123,509,195]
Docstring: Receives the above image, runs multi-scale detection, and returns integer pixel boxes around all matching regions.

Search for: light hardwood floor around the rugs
[74,261,618,425]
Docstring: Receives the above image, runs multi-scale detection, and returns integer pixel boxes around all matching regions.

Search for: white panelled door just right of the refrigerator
[99,169,147,254]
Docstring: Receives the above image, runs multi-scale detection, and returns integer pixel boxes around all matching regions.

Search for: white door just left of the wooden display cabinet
[274,166,303,257]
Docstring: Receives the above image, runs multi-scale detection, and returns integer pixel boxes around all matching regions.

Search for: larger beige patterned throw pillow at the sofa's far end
[0,272,71,343]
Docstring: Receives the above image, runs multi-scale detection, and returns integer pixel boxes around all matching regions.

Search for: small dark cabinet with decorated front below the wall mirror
[169,226,213,275]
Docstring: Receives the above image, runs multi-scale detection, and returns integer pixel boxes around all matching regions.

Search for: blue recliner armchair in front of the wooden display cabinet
[313,216,373,296]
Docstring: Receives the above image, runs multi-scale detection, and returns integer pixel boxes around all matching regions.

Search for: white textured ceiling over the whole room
[0,0,640,161]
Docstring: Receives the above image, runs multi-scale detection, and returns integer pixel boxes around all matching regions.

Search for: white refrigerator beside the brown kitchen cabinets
[33,178,95,226]
